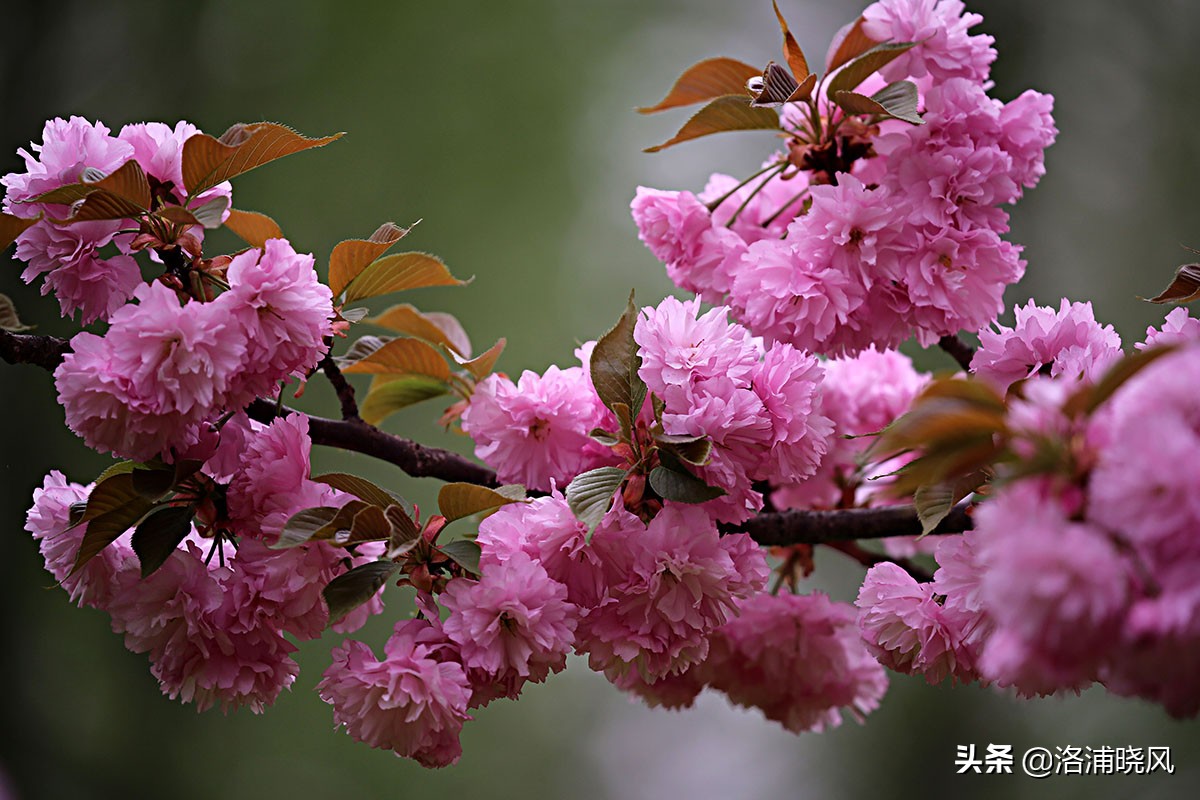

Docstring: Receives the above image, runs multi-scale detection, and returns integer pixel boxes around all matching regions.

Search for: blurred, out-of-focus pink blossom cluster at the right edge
[858,301,1200,717]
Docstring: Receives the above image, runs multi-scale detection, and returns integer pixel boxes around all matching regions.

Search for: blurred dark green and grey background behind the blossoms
[0,0,1200,800]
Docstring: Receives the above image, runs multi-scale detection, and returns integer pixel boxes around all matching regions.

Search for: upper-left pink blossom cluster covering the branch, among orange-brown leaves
[0,116,334,461]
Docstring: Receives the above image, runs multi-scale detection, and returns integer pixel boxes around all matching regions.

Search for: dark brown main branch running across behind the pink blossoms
[0,330,973,547]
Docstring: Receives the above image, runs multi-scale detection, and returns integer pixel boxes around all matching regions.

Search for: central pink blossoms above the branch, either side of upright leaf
[462,297,833,522]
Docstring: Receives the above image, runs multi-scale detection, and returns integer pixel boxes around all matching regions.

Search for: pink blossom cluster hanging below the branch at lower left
[25,414,383,712]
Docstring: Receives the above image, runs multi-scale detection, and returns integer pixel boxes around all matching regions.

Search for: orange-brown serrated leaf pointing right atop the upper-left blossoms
[182,122,342,197]
